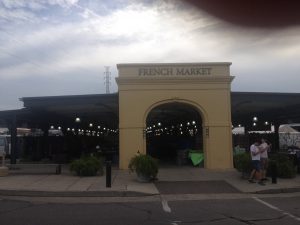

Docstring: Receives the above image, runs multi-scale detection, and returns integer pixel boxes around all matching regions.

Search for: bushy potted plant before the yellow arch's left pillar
[128,154,158,182]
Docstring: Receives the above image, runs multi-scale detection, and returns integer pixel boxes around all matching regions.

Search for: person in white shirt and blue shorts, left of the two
[248,140,265,185]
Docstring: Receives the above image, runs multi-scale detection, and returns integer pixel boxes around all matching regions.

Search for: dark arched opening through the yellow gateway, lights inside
[145,101,204,166]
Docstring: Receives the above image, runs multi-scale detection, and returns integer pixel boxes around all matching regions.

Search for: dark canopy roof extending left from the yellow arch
[0,94,119,128]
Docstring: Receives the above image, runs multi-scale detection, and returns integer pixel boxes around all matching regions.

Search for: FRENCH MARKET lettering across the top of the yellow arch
[139,67,212,76]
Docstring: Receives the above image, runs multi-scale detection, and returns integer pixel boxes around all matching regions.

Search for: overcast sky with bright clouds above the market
[0,0,300,110]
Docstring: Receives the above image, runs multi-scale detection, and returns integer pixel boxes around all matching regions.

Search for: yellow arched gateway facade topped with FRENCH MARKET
[117,63,233,169]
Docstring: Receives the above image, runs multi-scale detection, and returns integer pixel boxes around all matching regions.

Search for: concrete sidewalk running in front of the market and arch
[0,167,300,197]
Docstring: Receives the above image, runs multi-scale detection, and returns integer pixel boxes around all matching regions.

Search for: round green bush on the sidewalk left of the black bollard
[70,156,103,176]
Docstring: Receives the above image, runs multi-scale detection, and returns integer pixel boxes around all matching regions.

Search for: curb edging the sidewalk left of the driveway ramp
[0,190,158,197]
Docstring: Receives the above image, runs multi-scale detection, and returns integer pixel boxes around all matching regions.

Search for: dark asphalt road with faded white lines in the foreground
[0,194,300,225]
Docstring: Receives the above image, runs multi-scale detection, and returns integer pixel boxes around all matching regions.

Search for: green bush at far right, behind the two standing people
[269,154,297,178]
